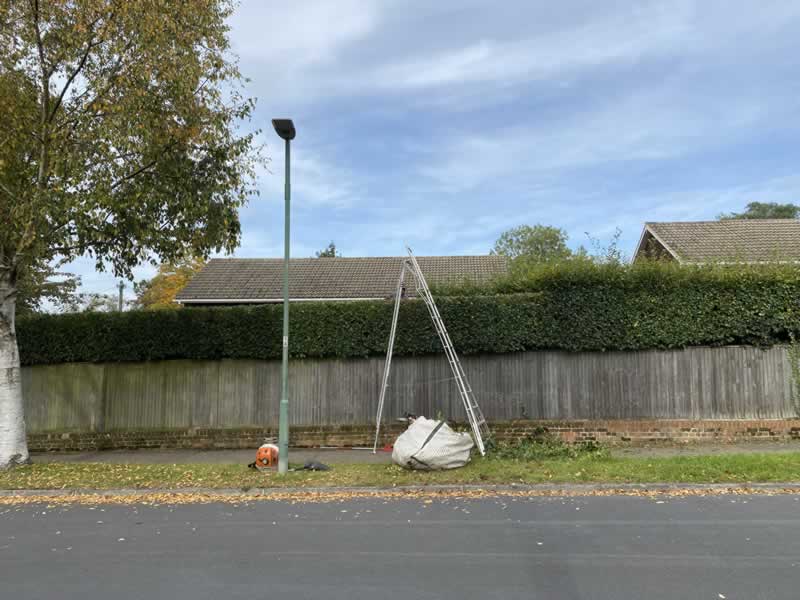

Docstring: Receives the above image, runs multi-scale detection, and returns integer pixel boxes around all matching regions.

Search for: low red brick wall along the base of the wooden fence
[28,419,800,452]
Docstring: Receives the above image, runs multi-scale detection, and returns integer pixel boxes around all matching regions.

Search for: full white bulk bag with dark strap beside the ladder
[392,417,474,471]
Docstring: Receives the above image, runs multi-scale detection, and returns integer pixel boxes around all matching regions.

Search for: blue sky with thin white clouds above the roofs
[72,0,800,296]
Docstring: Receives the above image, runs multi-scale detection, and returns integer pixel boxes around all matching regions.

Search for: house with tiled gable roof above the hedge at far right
[633,219,800,264]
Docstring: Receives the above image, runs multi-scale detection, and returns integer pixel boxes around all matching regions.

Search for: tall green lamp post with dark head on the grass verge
[272,119,296,473]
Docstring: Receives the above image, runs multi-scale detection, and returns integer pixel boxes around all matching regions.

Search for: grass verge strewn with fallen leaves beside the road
[0,452,800,489]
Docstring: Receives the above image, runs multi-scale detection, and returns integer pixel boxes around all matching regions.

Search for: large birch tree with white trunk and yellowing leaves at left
[0,0,258,468]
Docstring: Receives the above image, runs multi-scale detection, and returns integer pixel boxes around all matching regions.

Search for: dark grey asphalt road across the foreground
[0,496,800,600]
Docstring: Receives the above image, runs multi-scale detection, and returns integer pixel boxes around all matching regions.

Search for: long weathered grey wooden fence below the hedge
[22,346,797,433]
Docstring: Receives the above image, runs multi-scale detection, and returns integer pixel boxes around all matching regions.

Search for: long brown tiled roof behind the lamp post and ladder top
[176,256,508,304]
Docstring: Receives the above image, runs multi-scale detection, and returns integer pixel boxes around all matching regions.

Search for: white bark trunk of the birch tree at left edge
[0,270,30,470]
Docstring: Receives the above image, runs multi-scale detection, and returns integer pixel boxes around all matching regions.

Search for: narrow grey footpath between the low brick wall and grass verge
[33,442,800,464]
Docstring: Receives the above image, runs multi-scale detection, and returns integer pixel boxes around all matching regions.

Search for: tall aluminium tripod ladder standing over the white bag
[372,248,489,455]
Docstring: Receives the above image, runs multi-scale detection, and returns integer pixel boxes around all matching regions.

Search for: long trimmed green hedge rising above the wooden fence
[18,264,800,365]
